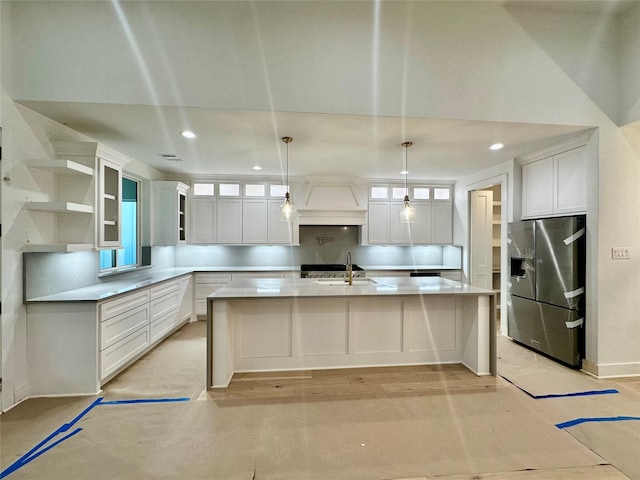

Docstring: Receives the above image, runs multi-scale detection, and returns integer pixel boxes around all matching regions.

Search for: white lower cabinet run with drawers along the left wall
[27,275,193,396]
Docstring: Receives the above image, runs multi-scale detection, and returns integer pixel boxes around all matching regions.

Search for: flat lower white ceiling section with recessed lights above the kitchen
[22,102,586,181]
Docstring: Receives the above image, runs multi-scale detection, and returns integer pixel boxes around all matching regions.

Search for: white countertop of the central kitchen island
[208,277,494,300]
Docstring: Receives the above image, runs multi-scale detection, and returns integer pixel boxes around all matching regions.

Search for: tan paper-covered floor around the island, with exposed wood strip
[0,322,640,480]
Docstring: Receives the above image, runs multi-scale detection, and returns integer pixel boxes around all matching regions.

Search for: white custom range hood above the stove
[297,178,367,225]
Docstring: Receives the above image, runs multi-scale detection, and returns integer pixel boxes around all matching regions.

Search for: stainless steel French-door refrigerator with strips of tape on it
[507,215,586,367]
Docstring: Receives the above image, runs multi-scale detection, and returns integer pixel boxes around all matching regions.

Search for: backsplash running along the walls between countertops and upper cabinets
[23,231,462,298]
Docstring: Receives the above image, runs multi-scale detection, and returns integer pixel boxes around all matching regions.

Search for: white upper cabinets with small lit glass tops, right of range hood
[362,185,453,245]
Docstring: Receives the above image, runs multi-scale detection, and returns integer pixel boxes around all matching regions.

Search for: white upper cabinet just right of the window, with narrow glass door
[153,182,189,246]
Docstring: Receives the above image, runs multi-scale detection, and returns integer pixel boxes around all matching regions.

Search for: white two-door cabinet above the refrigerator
[522,147,587,218]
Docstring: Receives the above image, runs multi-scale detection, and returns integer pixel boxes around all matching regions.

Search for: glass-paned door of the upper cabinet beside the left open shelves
[97,158,122,248]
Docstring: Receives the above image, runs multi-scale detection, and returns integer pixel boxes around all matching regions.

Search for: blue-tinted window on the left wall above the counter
[100,177,140,270]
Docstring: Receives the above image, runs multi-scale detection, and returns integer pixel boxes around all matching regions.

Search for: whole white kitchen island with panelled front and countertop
[207,277,496,388]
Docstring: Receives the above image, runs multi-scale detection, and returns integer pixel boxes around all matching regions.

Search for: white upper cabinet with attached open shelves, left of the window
[25,142,124,252]
